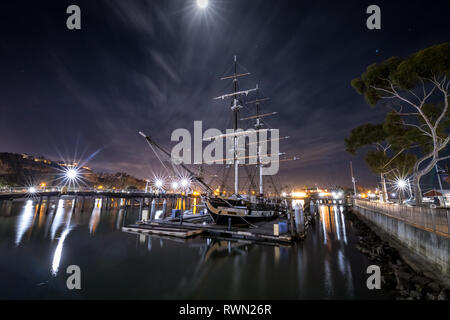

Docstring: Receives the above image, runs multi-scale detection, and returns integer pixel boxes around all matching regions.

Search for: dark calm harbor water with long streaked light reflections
[0,200,392,299]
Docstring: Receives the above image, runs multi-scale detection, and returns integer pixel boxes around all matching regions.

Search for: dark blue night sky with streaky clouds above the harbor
[0,0,450,186]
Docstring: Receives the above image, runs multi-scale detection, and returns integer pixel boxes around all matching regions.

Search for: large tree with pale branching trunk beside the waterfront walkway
[346,42,450,203]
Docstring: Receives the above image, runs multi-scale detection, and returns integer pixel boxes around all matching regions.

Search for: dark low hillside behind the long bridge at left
[0,152,145,189]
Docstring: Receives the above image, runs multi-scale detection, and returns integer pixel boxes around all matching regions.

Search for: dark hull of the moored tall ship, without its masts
[205,198,282,225]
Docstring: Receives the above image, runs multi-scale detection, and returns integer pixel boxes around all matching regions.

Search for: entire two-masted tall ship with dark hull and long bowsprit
[140,57,297,225]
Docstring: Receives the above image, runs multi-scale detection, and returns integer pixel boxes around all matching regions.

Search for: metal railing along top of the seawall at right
[354,199,450,237]
